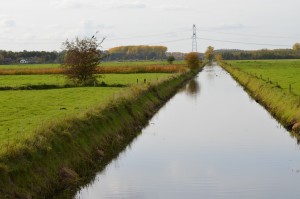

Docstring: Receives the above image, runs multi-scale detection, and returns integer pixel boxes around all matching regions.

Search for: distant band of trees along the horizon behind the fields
[0,43,300,64]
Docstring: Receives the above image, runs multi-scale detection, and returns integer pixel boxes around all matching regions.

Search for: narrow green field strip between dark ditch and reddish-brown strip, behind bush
[0,73,176,87]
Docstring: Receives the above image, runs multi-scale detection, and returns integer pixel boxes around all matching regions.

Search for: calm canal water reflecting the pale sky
[75,65,300,199]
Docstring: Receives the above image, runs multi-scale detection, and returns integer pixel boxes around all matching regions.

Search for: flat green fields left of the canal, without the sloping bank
[0,62,180,155]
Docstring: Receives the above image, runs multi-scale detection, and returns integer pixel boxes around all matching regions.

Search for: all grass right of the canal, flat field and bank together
[219,61,300,133]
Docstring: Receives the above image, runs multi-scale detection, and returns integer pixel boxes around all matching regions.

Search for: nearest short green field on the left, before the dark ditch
[0,87,121,150]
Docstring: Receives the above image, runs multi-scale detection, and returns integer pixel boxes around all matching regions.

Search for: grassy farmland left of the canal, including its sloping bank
[0,57,203,198]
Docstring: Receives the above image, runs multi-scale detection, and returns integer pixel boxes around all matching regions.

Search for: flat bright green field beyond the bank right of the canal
[226,60,300,95]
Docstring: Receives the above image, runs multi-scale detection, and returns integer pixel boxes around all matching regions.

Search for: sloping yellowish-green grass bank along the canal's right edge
[219,62,300,133]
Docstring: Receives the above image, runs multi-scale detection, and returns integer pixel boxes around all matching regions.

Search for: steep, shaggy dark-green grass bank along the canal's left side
[0,65,204,198]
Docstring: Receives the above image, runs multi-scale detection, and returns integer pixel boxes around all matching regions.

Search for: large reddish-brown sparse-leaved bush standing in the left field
[62,36,104,85]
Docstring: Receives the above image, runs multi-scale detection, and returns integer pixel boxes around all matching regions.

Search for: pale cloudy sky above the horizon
[0,0,300,52]
